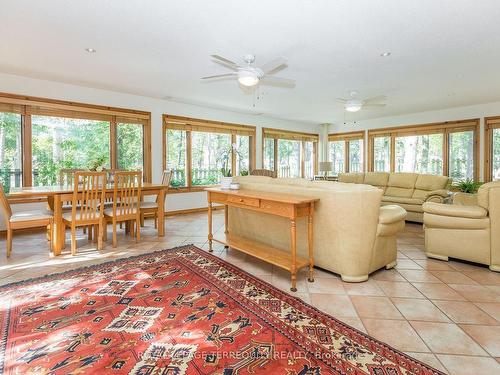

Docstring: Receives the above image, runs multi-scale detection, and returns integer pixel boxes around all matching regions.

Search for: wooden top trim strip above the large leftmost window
[0,92,151,120]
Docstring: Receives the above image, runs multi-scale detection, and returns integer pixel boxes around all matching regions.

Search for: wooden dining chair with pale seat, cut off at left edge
[0,183,54,257]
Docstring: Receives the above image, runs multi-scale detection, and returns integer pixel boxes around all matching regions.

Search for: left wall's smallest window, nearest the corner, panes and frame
[262,128,319,178]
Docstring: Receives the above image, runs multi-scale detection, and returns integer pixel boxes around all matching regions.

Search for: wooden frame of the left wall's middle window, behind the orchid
[162,114,256,194]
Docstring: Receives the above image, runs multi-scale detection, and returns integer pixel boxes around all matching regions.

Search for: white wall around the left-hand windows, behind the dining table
[0,73,319,229]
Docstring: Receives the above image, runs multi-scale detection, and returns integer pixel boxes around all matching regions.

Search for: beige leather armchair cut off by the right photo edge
[423,181,500,272]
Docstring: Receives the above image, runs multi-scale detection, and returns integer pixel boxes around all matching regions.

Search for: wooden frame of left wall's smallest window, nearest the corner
[261,128,319,178]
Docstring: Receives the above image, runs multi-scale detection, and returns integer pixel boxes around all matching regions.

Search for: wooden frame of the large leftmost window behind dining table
[0,93,152,191]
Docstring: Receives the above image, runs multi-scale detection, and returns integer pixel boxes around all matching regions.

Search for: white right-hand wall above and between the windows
[330,102,500,180]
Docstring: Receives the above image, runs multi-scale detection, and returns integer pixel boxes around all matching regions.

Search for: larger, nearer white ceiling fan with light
[201,55,295,88]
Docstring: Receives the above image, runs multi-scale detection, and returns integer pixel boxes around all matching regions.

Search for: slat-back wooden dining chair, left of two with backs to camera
[62,172,106,255]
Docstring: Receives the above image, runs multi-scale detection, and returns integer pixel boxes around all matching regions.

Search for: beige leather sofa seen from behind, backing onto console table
[228,176,406,282]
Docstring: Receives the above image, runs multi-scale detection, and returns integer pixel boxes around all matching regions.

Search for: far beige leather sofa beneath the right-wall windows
[339,172,451,223]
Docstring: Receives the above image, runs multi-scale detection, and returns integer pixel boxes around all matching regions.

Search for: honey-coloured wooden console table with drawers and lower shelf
[205,188,319,292]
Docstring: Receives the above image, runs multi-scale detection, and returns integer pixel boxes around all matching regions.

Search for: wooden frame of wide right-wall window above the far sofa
[368,118,480,181]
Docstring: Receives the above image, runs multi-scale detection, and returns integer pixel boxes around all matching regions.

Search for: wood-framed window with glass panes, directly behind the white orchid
[163,115,255,191]
